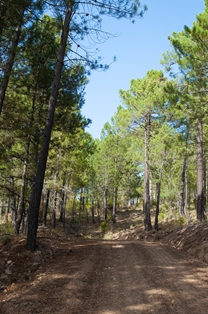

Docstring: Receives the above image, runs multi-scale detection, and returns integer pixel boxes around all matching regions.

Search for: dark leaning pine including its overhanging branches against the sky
[27,0,146,251]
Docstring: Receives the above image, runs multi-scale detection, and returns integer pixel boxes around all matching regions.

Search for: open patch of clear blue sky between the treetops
[82,0,204,138]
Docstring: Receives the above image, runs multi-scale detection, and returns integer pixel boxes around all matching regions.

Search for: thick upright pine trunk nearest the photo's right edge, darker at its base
[196,118,205,222]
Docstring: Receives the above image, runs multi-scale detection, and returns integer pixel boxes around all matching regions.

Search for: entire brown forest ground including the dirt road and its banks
[0,210,208,314]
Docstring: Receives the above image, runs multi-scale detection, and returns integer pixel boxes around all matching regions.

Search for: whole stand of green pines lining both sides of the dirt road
[0,0,208,251]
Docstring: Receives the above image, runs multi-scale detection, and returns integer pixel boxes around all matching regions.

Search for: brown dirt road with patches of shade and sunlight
[0,240,208,314]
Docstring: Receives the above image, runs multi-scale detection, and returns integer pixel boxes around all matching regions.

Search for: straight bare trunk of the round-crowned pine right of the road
[144,115,152,231]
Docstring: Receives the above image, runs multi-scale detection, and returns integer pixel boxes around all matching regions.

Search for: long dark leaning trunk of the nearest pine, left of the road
[27,1,72,251]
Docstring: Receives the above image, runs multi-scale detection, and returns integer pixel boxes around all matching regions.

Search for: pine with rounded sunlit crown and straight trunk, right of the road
[120,70,165,230]
